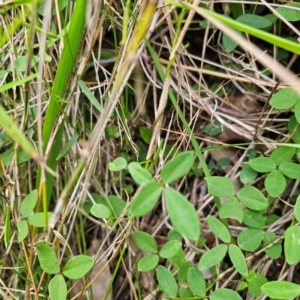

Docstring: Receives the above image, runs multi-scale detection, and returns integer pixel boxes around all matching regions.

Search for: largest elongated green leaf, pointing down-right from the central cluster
[164,187,200,241]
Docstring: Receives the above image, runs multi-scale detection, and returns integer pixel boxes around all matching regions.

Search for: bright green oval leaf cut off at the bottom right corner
[261,281,300,299]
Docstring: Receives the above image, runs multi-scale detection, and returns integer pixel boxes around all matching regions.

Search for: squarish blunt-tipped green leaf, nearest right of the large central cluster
[206,176,234,197]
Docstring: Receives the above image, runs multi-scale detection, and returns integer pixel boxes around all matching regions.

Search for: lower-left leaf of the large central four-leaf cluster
[129,182,162,217]
